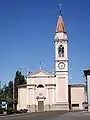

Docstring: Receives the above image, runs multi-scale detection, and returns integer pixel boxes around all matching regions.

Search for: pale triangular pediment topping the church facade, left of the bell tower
[31,69,54,77]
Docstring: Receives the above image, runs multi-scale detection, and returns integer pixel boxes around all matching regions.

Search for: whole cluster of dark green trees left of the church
[0,71,26,109]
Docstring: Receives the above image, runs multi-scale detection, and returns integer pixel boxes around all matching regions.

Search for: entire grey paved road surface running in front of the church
[0,111,90,120]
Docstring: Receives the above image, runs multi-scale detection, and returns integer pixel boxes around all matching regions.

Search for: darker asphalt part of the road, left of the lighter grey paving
[0,111,67,120]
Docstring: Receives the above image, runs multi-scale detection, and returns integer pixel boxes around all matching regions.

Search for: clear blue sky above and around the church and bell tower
[0,0,90,84]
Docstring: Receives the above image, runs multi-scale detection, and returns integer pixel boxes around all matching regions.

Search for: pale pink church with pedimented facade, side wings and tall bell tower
[17,11,84,112]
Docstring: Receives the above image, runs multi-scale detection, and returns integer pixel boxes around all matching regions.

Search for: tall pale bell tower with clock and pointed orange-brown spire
[55,7,69,110]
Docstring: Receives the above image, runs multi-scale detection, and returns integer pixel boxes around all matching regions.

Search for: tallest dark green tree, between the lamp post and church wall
[14,71,26,109]
